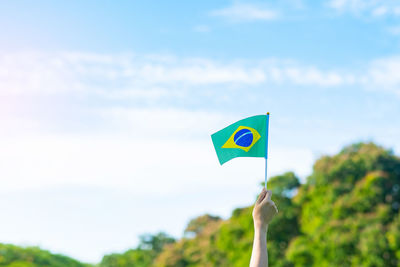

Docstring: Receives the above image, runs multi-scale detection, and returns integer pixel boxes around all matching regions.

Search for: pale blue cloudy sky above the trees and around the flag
[0,0,400,263]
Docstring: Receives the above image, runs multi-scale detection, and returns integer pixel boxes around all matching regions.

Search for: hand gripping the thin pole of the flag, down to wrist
[253,188,278,231]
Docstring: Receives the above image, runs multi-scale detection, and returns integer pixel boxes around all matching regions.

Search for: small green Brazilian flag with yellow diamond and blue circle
[211,113,269,165]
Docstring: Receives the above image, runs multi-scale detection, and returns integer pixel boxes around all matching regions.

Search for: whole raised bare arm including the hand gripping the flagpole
[250,189,278,267]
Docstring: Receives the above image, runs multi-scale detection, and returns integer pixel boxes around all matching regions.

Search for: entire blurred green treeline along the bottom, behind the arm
[0,143,400,267]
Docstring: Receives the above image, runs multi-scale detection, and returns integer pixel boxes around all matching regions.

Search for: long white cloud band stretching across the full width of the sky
[0,51,399,99]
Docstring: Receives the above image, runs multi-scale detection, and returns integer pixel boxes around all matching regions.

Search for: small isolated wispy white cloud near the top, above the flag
[210,3,279,21]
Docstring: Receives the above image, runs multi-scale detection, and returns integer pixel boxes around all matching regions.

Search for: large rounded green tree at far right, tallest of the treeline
[287,143,400,266]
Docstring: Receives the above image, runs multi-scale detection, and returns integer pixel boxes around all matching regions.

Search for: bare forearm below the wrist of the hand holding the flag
[250,226,268,267]
